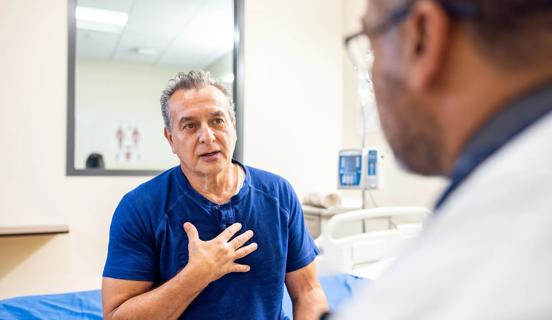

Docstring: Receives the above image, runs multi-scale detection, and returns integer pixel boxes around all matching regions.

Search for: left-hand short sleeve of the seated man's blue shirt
[103,195,159,281]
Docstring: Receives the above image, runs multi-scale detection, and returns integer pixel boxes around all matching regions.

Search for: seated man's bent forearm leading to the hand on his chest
[106,266,209,320]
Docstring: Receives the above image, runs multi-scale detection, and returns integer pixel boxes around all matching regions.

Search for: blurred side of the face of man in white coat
[363,0,442,175]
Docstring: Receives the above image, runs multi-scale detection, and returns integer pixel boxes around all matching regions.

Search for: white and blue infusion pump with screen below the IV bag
[337,148,382,190]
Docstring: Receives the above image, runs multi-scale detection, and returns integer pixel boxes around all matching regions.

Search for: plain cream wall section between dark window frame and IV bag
[244,0,342,194]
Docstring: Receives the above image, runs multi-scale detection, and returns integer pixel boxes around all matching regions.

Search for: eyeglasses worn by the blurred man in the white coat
[345,0,478,74]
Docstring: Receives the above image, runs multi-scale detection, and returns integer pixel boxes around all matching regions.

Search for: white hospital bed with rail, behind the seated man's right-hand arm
[315,207,431,280]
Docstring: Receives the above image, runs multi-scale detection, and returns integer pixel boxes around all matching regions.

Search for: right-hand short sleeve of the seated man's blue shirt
[286,183,319,272]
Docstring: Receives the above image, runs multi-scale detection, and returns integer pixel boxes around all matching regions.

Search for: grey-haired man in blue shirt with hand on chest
[102,71,327,319]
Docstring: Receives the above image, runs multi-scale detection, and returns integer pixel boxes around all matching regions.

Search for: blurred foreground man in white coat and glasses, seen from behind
[341,0,552,319]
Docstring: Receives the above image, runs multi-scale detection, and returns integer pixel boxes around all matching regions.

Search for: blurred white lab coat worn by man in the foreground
[338,114,552,320]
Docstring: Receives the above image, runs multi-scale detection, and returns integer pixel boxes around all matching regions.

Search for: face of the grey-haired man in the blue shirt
[165,86,237,176]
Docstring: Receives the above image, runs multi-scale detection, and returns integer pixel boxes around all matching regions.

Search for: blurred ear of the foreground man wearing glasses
[403,0,451,93]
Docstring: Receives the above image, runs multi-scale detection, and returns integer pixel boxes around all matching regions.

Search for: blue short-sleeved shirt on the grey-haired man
[103,165,318,319]
